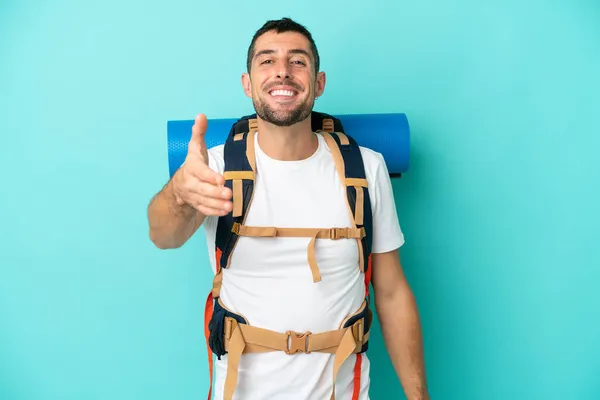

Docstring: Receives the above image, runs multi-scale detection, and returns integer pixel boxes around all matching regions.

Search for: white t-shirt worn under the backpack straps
[203,130,404,400]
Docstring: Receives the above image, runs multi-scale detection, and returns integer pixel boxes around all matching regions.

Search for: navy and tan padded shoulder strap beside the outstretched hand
[215,114,258,268]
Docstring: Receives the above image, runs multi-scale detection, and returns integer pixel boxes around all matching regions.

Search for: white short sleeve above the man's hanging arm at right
[369,152,404,253]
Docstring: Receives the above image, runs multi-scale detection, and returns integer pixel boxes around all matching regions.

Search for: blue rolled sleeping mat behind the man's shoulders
[167,113,410,176]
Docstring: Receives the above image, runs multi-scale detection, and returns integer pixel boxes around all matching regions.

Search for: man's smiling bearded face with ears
[242,31,325,126]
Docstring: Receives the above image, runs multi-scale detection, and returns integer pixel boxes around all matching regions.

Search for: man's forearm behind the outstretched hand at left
[148,180,204,249]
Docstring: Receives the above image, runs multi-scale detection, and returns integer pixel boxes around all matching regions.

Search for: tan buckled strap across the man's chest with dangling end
[231,222,366,282]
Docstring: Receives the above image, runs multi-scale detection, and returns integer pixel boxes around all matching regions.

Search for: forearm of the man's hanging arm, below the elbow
[375,287,429,400]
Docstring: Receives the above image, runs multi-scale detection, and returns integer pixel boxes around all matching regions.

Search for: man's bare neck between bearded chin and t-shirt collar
[258,116,318,161]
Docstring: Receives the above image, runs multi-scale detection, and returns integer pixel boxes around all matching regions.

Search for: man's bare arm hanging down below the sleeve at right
[372,250,429,400]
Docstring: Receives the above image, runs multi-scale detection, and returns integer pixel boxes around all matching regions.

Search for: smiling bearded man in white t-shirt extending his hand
[148,19,429,400]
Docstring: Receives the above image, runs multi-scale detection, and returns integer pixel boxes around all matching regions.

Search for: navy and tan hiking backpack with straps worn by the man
[204,112,373,400]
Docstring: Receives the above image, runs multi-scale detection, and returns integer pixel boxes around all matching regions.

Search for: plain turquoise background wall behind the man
[0,0,600,400]
